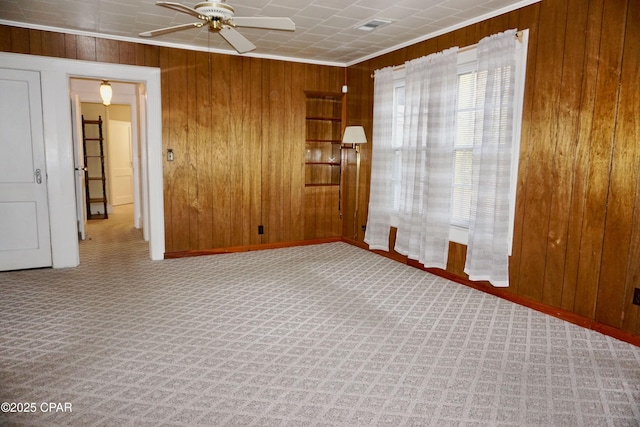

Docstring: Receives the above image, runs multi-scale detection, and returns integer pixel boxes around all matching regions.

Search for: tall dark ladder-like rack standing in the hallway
[82,115,109,219]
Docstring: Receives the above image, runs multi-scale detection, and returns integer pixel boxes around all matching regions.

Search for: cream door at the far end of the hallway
[107,120,133,206]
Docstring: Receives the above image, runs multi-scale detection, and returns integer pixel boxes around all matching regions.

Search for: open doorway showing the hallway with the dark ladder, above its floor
[70,78,148,262]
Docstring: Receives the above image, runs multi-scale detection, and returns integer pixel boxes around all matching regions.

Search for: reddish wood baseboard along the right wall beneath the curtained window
[342,238,640,347]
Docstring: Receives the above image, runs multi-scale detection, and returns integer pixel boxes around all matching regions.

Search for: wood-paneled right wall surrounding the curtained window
[344,0,640,336]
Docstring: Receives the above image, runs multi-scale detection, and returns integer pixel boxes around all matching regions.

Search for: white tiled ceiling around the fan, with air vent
[0,0,539,65]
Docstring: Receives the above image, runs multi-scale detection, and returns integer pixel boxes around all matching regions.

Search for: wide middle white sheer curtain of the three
[395,47,458,268]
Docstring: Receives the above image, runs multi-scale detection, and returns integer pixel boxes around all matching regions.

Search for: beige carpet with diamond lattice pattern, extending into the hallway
[0,209,640,427]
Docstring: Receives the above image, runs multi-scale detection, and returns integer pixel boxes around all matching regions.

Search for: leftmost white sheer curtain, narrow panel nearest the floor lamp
[364,67,395,251]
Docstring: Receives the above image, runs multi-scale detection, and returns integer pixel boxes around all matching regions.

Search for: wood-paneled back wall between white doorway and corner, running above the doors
[0,26,345,253]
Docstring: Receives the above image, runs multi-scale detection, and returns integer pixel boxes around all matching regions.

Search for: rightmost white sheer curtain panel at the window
[464,30,516,287]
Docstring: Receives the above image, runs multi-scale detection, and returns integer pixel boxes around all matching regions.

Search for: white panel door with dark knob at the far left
[0,68,52,271]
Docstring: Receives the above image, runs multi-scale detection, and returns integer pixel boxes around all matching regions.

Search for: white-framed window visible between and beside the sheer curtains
[391,35,528,249]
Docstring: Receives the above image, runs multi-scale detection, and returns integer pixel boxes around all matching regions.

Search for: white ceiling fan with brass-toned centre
[140,0,296,53]
